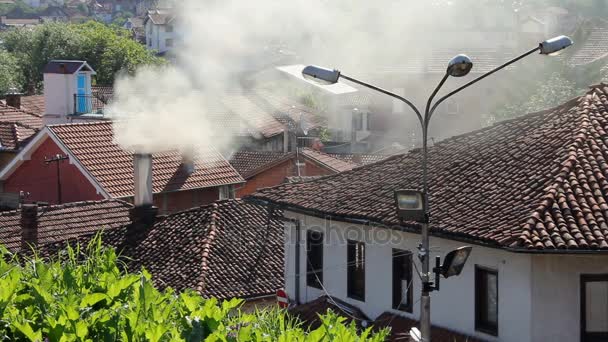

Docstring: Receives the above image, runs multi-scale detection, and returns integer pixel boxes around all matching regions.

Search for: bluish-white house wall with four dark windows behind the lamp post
[285,212,533,342]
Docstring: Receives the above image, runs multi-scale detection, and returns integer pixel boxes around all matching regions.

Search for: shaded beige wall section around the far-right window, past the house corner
[532,255,608,341]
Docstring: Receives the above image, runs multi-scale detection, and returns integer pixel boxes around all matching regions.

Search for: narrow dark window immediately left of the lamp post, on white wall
[393,249,413,312]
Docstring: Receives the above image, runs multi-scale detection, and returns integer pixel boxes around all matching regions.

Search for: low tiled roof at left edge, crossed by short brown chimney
[0,200,131,251]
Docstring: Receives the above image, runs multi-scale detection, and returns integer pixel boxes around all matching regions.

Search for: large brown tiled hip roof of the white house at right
[254,84,608,250]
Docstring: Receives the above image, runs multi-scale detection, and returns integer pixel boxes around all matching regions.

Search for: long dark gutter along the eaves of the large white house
[243,196,608,255]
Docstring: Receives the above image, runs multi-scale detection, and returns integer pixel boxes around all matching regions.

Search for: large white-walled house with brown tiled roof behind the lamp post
[251,84,608,341]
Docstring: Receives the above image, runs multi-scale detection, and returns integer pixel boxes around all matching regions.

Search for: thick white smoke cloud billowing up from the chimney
[107,0,512,151]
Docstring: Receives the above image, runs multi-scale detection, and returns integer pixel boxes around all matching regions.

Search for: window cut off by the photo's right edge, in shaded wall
[581,274,608,342]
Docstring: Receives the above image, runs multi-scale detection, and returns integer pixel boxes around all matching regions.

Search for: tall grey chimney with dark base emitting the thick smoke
[129,153,158,231]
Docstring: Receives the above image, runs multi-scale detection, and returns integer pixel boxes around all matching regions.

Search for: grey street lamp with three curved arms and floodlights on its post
[302,36,572,341]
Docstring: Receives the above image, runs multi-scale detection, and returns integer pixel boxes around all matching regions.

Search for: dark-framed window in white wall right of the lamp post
[475,265,498,336]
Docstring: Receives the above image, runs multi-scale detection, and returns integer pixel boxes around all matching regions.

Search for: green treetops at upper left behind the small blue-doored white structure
[1,21,164,92]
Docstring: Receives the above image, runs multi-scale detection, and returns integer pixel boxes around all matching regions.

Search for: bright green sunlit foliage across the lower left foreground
[0,236,386,342]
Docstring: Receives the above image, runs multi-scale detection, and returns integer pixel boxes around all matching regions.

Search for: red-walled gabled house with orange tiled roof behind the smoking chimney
[0,121,243,212]
